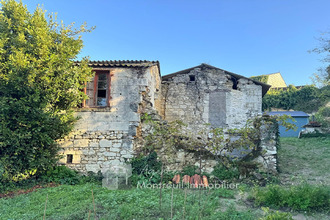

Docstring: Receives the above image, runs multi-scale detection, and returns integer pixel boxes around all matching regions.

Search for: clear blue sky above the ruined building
[22,0,330,86]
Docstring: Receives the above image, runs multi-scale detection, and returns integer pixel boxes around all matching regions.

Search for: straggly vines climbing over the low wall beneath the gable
[142,116,268,174]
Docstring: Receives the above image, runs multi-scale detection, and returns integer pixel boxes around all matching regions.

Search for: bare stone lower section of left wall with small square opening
[59,131,133,173]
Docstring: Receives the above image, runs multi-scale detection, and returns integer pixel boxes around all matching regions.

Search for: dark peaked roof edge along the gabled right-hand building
[162,63,271,96]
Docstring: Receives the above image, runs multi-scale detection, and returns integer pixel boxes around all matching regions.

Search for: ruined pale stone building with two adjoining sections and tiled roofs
[60,61,270,172]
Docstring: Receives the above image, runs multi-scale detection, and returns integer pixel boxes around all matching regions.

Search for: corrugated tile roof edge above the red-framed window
[75,60,159,68]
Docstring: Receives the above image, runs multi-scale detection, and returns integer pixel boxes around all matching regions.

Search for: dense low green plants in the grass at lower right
[252,183,330,211]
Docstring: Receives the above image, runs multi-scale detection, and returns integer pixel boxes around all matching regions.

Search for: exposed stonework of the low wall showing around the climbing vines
[138,117,279,173]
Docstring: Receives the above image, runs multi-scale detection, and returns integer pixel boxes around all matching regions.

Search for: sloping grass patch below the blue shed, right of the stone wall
[278,137,330,185]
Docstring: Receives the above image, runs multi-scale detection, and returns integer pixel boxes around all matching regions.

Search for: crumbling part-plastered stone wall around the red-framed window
[59,66,160,172]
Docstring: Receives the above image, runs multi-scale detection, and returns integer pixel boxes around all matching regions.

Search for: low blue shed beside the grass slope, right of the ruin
[267,111,309,137]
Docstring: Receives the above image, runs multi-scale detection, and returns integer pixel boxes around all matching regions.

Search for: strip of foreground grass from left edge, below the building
[0,184,256,220]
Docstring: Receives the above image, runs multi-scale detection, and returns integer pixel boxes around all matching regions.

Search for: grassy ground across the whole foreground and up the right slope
[0,138,330,220]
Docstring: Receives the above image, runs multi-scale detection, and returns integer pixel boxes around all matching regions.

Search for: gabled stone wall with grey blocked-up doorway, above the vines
[162,68,262,128]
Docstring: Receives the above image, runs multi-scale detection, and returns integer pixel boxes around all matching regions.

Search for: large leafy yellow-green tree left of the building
[0,0,91,179]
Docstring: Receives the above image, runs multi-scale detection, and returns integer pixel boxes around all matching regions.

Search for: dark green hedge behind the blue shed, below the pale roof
[262,85,330,113]
